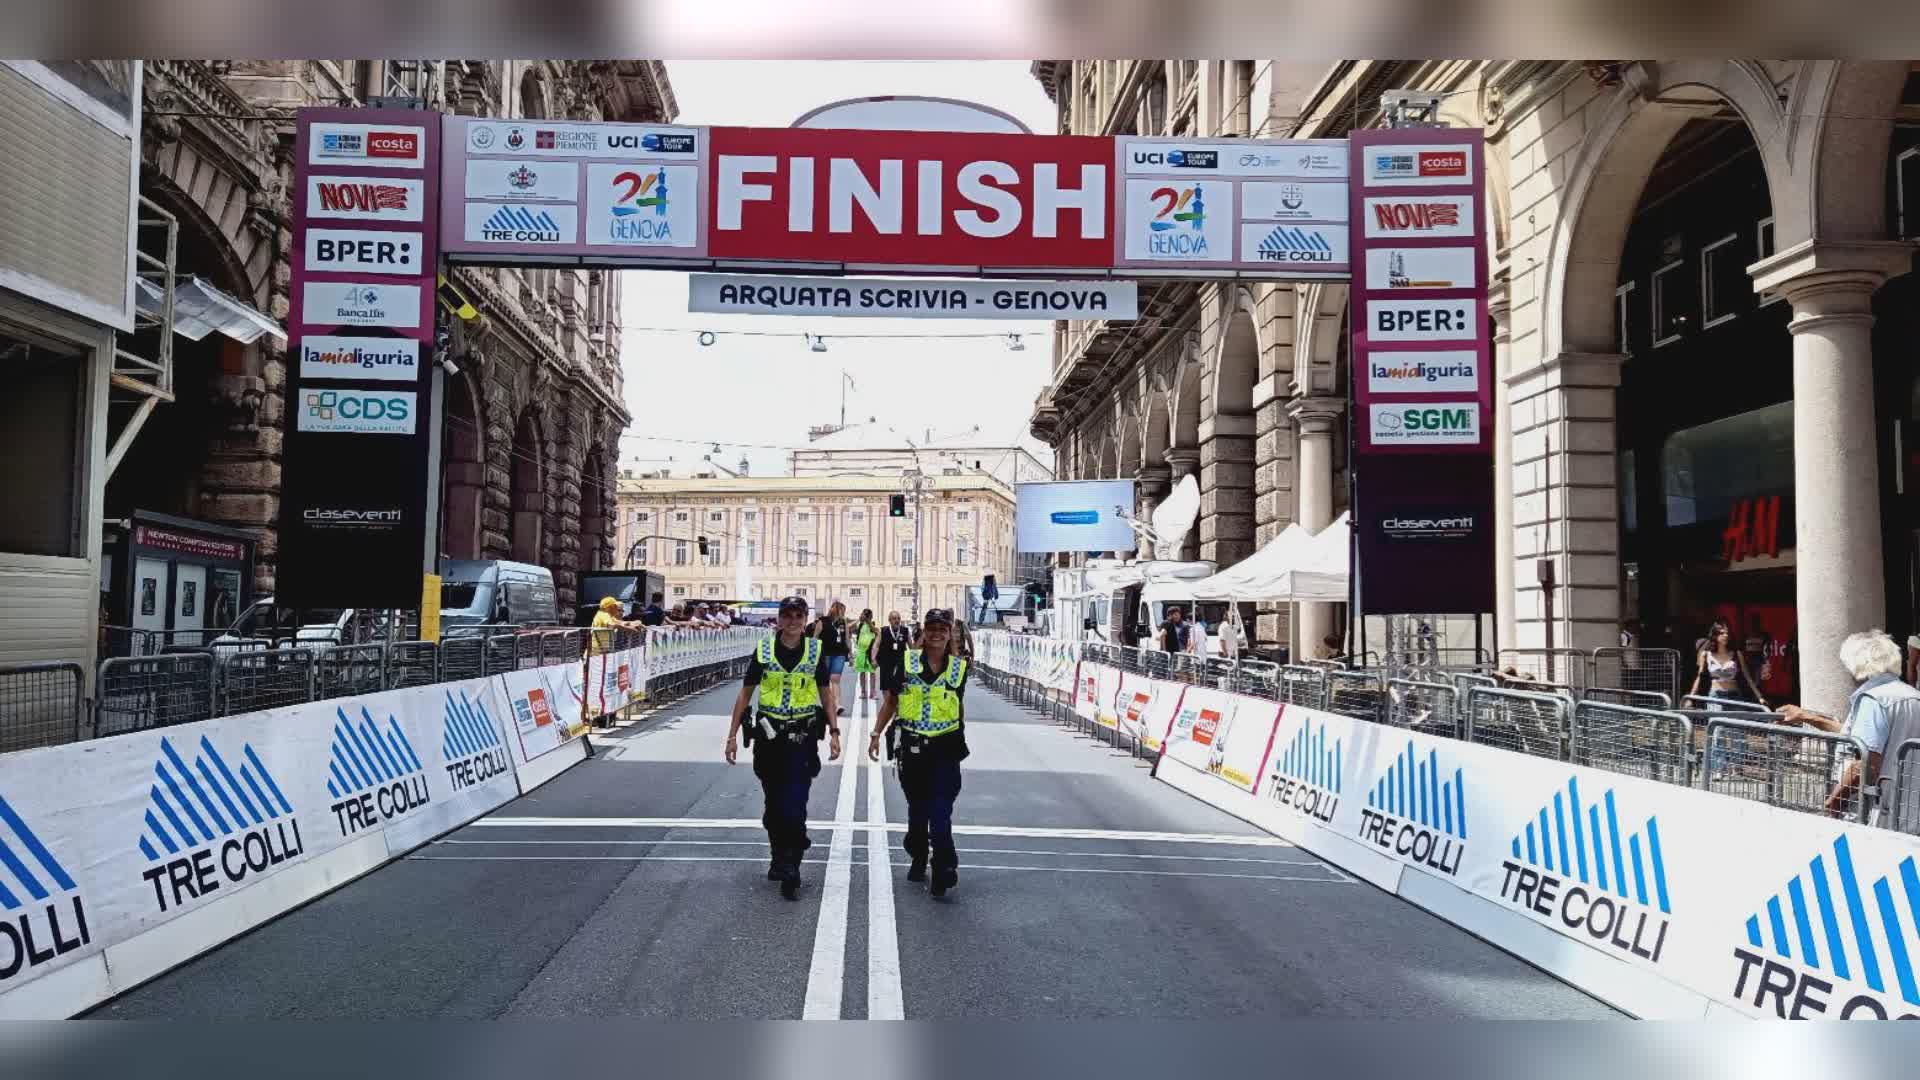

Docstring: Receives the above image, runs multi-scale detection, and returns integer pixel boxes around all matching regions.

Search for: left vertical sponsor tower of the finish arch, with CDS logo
[276,110,440,607]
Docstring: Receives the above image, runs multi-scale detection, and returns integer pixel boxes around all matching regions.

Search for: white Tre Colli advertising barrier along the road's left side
[0,678,520,1019]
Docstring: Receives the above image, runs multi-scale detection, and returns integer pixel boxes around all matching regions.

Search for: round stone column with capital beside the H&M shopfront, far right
[1749,240,1912,717]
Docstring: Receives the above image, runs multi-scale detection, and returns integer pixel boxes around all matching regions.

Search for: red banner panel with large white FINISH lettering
[707,127,1114,269]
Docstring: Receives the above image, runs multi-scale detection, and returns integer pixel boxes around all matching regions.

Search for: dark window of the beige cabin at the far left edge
[0,325,86,557]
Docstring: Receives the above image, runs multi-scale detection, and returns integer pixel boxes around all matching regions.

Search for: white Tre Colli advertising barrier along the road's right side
[1121,672,1920,1019]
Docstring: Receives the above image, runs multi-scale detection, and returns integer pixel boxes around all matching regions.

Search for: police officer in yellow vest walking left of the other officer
[726,596,839,899]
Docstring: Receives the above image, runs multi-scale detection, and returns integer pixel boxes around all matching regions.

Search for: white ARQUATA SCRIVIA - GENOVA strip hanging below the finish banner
[687,273,1139,321]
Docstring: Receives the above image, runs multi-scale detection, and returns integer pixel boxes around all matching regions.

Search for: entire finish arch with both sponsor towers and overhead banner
[282,110,1492,611]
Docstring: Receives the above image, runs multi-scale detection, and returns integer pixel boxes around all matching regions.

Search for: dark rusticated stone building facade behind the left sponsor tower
[121,60,678,609]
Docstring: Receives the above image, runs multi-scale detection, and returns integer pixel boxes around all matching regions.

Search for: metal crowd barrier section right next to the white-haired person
[1699,715,1872,822]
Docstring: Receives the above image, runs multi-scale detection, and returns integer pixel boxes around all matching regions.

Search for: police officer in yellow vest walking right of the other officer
[866,607,968,896]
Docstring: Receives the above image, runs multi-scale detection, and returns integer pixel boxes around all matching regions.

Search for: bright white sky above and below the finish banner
[620,61,1056,475]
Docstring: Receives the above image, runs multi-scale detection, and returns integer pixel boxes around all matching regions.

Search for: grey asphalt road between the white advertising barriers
[94,686,1613,1019]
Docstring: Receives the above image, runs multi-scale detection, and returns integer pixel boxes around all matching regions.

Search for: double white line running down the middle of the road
[801,717,906,1020]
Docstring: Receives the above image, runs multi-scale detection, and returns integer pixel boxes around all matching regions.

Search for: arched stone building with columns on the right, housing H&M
[1033,60,1920,709]
